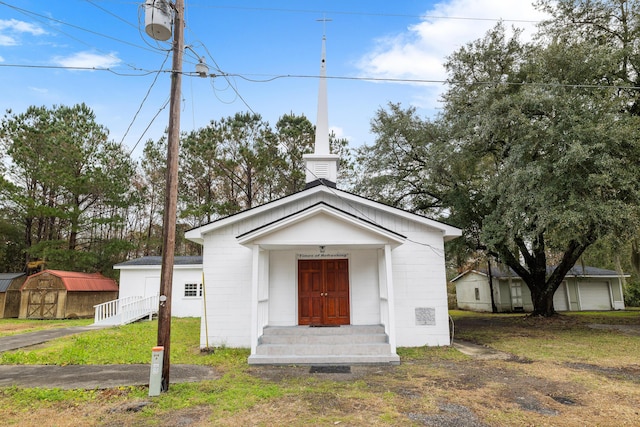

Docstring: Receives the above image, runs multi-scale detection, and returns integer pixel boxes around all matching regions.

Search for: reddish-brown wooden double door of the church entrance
[298,259,351,326]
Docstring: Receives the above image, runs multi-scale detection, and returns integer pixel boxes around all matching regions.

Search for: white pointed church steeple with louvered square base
[304,31,340,187]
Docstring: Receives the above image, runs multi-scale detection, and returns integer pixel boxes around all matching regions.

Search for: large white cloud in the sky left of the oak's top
[357,0,544,110]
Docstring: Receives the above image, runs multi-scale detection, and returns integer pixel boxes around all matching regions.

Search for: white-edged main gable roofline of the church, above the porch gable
[185,185,462,243]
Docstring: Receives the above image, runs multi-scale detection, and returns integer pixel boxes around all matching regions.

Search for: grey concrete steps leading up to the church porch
[249,325,400,365]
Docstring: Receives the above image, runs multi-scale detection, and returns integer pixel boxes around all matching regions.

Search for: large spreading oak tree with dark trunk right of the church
[361,16,640,316]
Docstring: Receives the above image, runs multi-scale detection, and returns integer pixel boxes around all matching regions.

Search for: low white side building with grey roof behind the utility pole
[113,256,203,317]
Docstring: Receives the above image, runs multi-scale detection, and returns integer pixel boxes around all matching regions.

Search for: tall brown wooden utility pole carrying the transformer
[158,0,184,391]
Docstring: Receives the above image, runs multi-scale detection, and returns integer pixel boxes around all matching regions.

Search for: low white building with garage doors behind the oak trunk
[452,265,630,312]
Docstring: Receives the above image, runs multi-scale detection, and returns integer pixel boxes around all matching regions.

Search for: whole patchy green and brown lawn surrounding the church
[0,310,640,426]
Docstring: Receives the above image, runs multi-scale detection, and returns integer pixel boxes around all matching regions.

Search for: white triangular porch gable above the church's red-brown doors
[237,202,406,248]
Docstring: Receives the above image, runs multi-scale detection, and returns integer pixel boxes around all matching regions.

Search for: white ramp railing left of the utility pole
[93,295,159,325]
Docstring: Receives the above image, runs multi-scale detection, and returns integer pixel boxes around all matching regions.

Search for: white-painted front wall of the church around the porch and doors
[200,194,450,347]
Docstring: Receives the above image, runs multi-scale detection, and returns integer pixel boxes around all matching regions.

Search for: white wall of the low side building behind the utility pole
[118,265,202,317]
